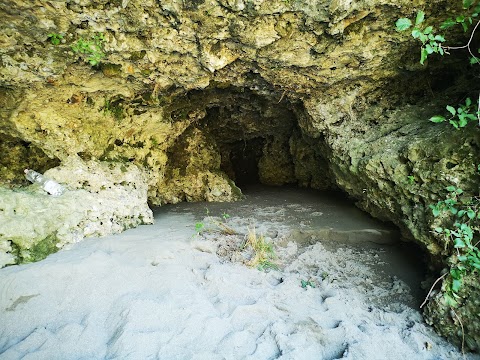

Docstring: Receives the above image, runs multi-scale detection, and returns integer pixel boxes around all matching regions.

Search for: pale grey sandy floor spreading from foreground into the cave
[0,188,480,360]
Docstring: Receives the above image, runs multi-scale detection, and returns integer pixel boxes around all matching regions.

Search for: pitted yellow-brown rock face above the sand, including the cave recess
[0,0,480,350]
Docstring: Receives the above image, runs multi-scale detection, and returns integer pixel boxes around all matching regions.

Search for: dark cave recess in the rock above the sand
[185,87,334,189]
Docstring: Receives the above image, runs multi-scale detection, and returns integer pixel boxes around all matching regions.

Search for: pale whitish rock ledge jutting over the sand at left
[0,157,153,267]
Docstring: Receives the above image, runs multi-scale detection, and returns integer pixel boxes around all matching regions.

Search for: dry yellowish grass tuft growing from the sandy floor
[244,227,278,271]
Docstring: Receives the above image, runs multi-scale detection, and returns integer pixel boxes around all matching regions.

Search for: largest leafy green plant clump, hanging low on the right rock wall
[430,186,480,307]
